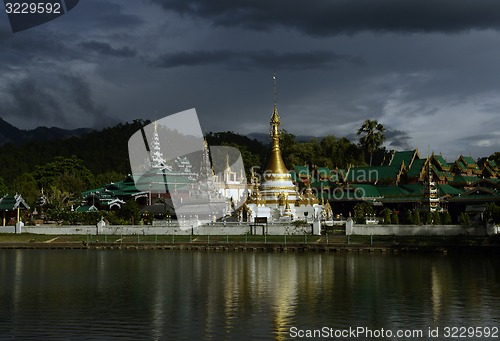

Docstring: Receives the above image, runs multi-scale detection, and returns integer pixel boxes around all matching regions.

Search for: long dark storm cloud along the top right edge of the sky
[151,0,500,36]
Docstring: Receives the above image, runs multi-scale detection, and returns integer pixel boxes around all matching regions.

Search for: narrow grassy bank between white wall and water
[0,233,500,254]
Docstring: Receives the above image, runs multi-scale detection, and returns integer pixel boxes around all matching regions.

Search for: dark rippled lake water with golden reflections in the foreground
[0,250,500,340]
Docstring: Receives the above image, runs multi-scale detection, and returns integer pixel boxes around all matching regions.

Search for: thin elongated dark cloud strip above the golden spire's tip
[151,50,361,70]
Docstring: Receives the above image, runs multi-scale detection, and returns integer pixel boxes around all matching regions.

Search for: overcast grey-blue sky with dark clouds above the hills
[0,0,500,161]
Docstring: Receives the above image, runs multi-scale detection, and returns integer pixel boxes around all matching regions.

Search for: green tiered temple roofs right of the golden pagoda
[293,149,500,215]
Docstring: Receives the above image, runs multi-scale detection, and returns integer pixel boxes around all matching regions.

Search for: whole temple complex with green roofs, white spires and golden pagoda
[75,77,500,223]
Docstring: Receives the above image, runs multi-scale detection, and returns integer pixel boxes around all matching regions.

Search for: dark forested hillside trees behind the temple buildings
[0,120,380,207]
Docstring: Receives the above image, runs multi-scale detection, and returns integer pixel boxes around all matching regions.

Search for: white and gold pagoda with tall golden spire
[247,77,321,220]
